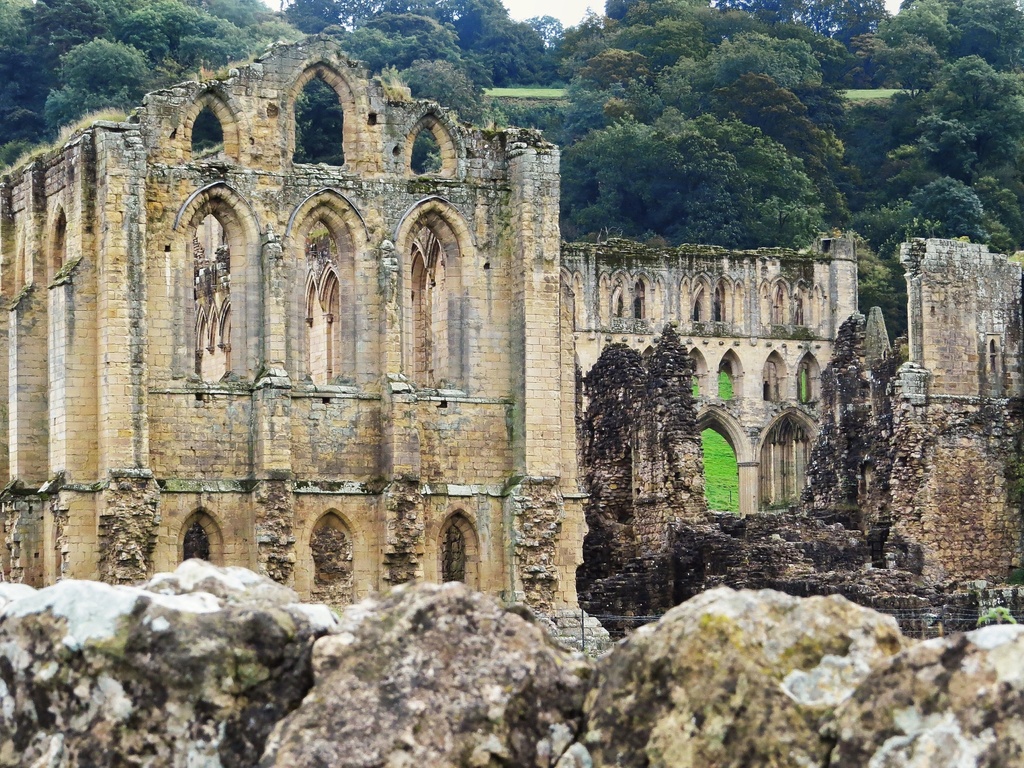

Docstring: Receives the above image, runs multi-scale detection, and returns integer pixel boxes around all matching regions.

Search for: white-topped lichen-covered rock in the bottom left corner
[0,561,336,768]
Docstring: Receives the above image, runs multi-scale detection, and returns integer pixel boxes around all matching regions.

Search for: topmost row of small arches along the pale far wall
[562,269,824,333]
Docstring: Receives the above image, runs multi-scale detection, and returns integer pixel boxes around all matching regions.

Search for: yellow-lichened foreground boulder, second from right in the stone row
[567,588,904,768]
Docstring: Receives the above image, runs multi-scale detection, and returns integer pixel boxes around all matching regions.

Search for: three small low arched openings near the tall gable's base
[178,509,480,605]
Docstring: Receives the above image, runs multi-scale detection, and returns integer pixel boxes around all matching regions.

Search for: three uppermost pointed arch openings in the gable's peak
[182,61,458,176]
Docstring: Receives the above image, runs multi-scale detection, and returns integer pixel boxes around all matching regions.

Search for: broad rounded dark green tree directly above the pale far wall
[562,111,820,247]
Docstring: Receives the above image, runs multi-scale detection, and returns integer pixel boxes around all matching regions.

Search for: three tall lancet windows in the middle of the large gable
[169,183,475,388]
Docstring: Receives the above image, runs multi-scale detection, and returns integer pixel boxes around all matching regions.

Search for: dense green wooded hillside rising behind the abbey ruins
[0,0,1024,330]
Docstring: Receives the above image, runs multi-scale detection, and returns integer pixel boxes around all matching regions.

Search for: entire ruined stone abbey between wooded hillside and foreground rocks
[0,38,1024,626]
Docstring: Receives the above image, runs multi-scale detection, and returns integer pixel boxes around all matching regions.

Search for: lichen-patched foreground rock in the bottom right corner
[829,625,1024,768]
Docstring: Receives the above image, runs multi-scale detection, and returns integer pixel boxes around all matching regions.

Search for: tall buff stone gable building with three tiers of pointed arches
[0,38,584,609]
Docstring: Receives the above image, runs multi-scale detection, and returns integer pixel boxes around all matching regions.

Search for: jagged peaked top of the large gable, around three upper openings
[0,35,558,192]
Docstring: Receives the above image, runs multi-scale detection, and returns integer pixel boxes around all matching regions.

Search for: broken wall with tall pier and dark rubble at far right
[807,240,1024,583]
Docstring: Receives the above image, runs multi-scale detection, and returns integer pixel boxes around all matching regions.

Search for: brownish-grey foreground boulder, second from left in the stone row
[260,583,590,768]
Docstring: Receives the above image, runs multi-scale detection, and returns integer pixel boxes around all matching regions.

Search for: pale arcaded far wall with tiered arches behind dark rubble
[562,239,857,515]
